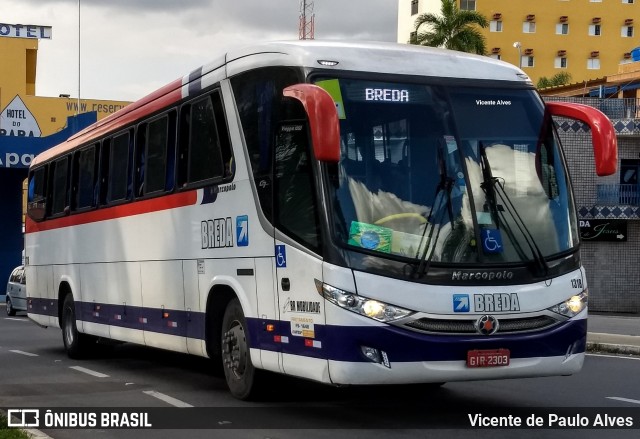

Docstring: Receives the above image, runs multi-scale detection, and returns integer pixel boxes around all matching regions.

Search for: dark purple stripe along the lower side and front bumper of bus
[29,298,587,362]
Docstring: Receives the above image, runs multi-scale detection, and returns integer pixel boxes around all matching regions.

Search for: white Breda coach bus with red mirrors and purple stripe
[26,41,617,398]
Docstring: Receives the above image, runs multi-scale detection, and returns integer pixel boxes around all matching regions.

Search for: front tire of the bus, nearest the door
[221,298,259,400]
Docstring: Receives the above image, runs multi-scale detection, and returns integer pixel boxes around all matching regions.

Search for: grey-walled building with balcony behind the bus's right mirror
[541,62,640,313]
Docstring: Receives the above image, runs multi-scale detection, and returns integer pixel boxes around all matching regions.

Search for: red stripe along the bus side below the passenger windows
[25,191,197,233]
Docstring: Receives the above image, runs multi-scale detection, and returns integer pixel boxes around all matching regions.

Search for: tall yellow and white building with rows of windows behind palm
[398,0,640,84]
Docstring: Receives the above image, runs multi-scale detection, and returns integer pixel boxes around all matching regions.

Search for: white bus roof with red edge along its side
[32,40,531,166]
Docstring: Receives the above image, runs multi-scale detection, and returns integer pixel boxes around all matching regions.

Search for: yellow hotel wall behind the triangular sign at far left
[0,37,129,137]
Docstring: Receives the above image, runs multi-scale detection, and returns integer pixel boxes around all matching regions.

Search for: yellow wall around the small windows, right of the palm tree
[476,0,640,83]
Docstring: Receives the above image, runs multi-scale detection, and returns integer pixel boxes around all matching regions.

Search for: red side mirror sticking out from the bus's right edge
[546,102,618,177]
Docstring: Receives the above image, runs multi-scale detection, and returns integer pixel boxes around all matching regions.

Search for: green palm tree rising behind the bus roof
[409,0,489,55]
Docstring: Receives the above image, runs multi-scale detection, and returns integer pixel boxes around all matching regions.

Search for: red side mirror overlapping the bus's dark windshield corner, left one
[282,84,340,163]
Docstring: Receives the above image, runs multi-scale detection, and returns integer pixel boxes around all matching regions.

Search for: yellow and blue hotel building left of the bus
[0,23,128,301]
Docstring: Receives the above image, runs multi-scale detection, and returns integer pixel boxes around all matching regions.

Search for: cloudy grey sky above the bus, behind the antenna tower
[0,0,398,101]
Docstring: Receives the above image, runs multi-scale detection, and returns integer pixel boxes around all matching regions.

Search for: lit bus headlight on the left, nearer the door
[316,279,414,323]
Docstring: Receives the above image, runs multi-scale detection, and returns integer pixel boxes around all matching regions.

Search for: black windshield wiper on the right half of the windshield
[479,142,549,276]
